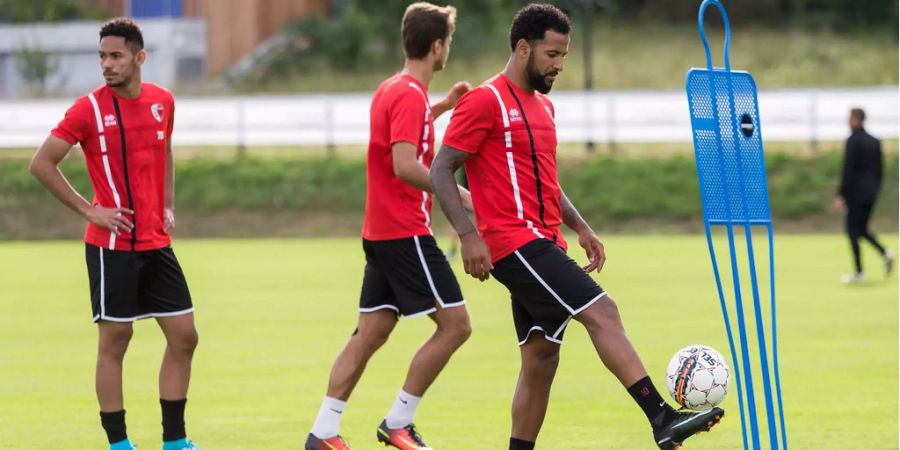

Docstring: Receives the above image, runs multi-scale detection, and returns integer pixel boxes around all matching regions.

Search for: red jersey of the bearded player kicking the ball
[444,74,567,262]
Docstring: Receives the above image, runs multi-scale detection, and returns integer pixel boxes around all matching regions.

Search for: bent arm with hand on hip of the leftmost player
[28,135,134,235]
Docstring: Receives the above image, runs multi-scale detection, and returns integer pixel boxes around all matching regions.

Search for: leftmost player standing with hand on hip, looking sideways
[30,18,198,450]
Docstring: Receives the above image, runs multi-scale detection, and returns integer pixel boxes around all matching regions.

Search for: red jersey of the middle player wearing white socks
[362,73,434,241]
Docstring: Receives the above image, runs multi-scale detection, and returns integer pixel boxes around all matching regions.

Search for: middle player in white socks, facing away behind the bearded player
[306,2,471,450]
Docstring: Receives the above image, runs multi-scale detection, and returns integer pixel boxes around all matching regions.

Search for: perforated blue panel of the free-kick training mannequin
[687,69,771,224]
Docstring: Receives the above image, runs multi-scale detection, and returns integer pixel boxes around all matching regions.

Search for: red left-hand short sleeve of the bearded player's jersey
[444,87,497,153]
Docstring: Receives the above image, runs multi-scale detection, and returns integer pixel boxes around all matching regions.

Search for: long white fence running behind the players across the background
[0,86,900,148]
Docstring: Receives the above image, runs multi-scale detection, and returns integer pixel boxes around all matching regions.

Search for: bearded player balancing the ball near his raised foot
[430,4,724,450]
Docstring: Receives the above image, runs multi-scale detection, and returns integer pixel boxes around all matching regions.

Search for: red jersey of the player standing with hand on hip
[51,83,175,251]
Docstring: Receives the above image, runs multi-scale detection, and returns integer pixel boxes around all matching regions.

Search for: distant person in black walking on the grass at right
[834,108,894,283]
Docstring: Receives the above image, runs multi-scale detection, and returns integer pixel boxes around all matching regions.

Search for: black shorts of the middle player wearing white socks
[359,235,466,318]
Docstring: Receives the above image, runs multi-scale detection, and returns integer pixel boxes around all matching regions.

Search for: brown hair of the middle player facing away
[400,2,456,59]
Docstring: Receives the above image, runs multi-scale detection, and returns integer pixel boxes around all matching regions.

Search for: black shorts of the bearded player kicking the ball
[491,239,606,345]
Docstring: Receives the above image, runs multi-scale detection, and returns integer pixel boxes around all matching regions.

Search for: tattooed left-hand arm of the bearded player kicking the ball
[428,145,494,281]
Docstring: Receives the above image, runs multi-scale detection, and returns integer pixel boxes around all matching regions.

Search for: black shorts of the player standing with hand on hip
[85,244,194,322]
